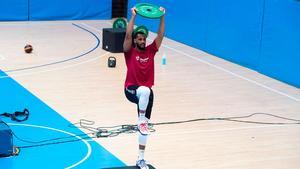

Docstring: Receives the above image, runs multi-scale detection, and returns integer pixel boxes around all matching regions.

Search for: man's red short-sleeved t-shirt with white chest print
[124,41,158,88]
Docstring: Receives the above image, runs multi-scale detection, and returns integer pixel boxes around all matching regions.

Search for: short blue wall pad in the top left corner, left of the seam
[0,0,28,21]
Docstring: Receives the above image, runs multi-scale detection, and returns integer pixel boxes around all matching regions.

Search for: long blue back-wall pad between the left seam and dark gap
[30,0,111,20]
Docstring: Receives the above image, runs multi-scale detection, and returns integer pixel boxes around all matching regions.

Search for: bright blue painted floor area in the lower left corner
[0,71,125,169]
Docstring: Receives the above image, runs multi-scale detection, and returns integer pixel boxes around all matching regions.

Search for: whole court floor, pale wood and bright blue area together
[0,20,300,169]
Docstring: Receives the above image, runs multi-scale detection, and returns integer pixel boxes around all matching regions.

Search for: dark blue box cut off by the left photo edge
[0,120,14,157]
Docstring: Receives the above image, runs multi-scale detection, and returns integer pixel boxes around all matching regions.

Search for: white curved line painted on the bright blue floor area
[8,123,92,169]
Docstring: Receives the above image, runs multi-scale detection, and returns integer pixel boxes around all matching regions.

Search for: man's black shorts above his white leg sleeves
[124,85,154,119]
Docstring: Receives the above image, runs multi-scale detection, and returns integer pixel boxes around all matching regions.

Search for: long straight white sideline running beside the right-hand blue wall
[97,21,300,102]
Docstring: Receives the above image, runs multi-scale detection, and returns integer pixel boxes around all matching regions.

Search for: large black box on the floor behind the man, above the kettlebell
[102,28,126,53]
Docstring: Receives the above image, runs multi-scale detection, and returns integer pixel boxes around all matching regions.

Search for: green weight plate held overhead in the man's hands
[135,3,164,19]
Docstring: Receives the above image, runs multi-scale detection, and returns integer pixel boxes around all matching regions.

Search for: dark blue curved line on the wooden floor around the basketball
[3,23,100,73]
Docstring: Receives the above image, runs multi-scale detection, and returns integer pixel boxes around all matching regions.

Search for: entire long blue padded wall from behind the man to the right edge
[128,0,300,87]
